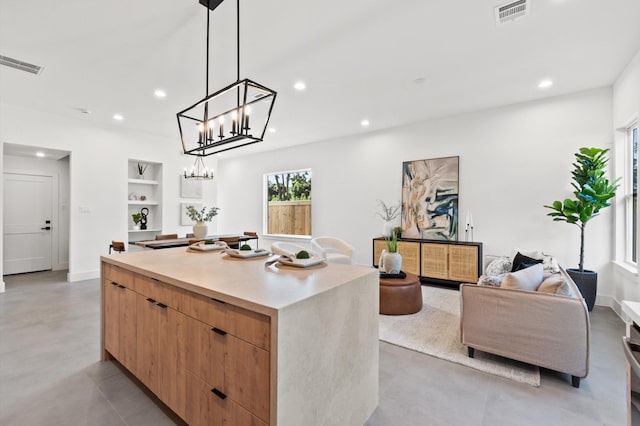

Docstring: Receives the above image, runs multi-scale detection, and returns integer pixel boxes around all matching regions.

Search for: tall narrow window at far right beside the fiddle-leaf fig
[625,122,638,264]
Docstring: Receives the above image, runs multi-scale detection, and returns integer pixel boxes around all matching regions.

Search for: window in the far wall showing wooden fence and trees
[264,169,311,237]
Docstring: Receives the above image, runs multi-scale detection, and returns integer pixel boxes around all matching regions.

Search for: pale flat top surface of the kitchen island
[100,247,378,313]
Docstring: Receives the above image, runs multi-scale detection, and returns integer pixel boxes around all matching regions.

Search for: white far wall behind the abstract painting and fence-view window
[218,88,614,295]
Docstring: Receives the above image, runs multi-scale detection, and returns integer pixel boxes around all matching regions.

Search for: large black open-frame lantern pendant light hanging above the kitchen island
[176,0,276,170]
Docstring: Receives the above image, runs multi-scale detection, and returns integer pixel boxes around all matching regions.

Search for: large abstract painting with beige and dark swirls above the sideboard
[402,157,460,241]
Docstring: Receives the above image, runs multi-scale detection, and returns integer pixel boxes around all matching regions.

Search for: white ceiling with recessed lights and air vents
[0,0,640,155]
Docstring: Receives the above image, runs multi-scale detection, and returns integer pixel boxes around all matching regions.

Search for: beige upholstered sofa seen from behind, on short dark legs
[460,269,590,388]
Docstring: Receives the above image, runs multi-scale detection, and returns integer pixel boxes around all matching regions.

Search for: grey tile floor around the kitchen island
[0,271,626,426]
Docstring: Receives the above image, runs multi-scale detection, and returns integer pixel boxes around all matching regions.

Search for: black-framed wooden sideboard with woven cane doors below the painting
[373,238,482,285]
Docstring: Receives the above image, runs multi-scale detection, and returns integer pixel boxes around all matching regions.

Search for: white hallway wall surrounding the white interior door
[3,155,70,270]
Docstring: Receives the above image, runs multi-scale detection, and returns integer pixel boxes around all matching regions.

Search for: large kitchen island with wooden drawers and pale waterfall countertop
[101,248,379,426]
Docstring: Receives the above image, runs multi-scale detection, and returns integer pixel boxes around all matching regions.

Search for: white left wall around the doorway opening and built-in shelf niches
[0,104,216,281]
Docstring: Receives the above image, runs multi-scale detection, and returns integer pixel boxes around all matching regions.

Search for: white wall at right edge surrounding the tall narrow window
[612,51,640,314]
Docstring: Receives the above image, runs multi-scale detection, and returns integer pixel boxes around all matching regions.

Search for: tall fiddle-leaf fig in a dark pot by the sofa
[544,148,620,311]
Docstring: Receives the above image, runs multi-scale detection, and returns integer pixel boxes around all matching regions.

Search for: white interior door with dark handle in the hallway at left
[3,173,53,275]
